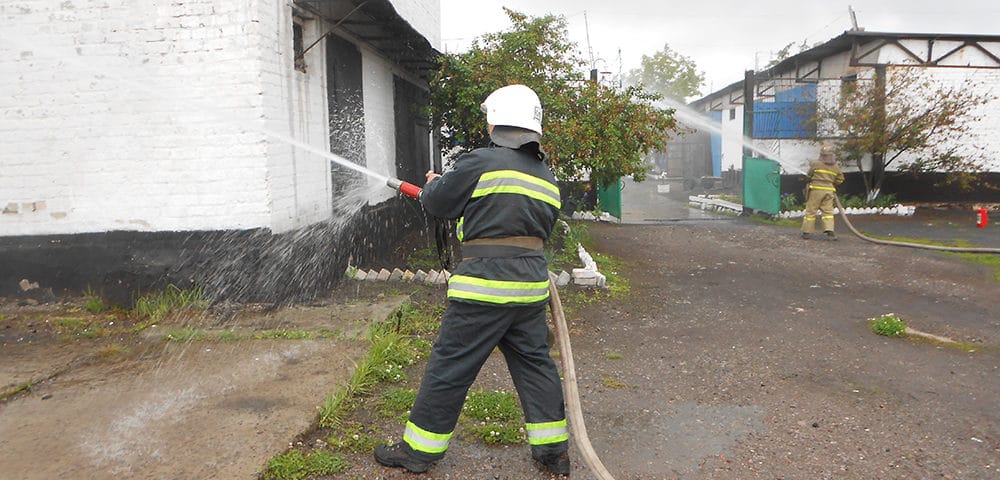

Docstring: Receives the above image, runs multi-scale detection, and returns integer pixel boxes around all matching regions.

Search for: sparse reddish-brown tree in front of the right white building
[820,67,997,201]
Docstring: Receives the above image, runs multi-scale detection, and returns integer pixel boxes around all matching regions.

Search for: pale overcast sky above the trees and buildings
[441,0,1000,94]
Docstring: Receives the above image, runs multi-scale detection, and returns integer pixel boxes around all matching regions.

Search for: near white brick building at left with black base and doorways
[0,0,440,304]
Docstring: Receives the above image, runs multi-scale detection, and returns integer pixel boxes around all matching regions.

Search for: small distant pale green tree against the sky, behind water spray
[628,44,705,101]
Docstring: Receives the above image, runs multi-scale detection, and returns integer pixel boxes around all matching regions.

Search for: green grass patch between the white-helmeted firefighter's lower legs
[462,390,525,444]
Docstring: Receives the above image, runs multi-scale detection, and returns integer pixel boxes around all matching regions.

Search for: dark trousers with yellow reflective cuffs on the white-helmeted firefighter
[404,301,569,461]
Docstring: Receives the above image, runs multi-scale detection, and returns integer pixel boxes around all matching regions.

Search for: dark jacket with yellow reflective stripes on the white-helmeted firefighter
[420,143,560,306]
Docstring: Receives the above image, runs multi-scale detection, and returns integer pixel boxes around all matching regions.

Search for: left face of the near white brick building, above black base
[0,0,268,235]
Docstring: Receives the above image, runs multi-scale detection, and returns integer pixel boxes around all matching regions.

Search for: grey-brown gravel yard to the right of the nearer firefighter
[332,212,1000,480]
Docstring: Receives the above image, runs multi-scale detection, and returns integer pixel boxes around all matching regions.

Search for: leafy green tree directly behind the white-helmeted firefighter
[431,9,675,186]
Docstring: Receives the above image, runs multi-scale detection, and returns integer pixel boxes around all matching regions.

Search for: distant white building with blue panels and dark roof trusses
[690,30,1000,202]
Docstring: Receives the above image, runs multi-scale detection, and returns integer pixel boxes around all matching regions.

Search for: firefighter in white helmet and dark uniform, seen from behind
[375,85,570,475]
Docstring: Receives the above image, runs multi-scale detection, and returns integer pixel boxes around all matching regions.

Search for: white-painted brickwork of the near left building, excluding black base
[0,0,440,236]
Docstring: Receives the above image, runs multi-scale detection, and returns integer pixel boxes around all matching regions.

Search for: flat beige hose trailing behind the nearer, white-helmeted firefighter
[549,272,614,480]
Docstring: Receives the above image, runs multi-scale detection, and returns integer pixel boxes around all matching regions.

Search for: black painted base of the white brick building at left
[0,197,434,306]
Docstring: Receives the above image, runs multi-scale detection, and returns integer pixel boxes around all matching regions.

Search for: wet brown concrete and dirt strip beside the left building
[0,296,405,480]
